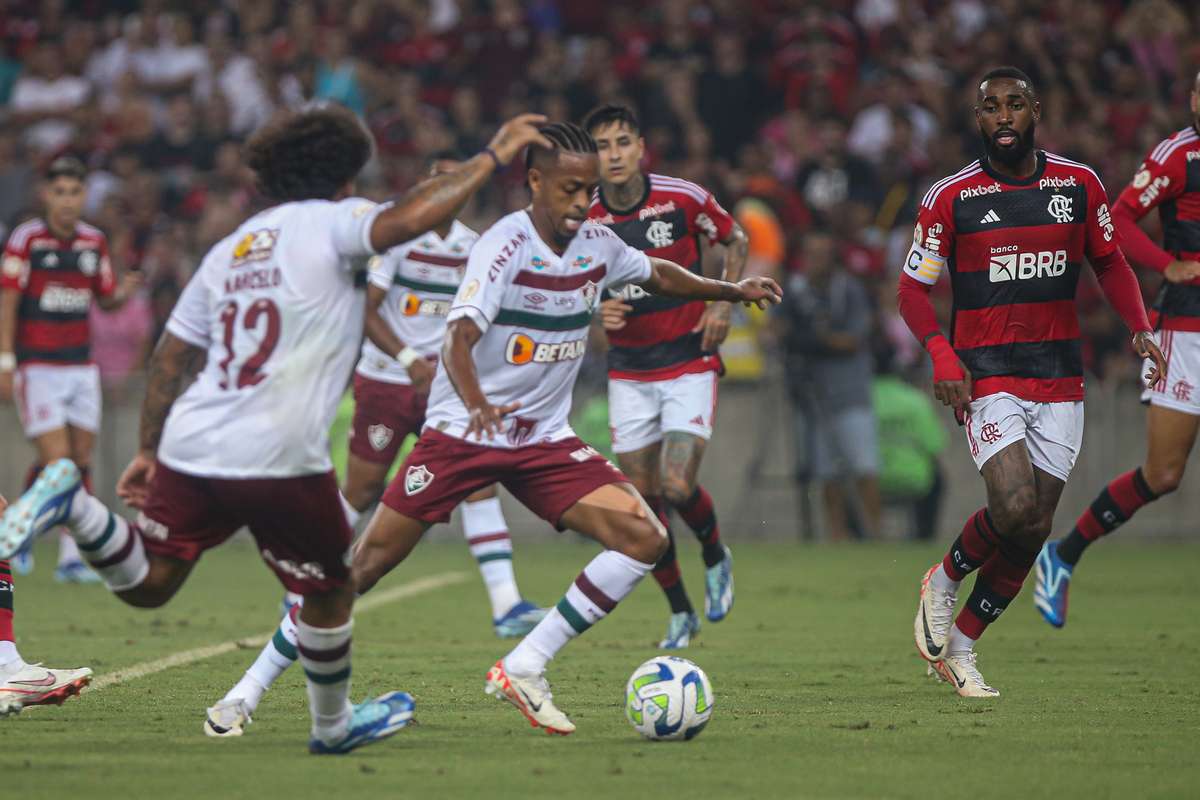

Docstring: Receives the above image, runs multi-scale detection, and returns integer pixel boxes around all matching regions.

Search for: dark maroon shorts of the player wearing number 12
[138,462,353,595]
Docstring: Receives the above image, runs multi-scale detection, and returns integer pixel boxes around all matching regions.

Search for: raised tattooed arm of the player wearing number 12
[371,114,552,253]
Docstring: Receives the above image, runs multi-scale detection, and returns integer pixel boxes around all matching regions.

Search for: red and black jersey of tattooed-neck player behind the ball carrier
[588,174,734,380]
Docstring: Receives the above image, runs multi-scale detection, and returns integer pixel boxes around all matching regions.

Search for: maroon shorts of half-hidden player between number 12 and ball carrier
[350,373,430,467]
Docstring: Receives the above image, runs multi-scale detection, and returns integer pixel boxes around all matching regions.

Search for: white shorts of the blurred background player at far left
[13,363,100,439]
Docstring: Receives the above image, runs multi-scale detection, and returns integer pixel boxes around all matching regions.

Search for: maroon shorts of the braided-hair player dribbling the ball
[383,428,629,529]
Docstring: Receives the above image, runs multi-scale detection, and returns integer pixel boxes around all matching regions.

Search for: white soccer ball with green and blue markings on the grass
[625,656,713,741]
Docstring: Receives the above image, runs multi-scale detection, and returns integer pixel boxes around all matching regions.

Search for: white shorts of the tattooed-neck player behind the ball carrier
[608,372,718,453]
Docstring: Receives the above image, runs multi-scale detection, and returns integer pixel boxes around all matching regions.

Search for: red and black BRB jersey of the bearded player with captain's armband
[905,151,1117,402]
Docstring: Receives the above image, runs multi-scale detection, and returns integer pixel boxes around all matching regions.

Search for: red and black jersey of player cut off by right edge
[1116,126,1200,331]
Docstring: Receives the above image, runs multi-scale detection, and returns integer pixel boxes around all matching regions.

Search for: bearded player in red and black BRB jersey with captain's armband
[899,67,1165,697]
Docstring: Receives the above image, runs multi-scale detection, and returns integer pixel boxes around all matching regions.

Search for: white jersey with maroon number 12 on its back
[158,198,383,479]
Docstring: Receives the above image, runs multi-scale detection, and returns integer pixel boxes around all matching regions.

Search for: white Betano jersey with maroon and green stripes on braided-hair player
[425,211,650,447]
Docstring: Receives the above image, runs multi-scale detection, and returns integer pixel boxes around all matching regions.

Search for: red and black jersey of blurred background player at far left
[0,218,116,363]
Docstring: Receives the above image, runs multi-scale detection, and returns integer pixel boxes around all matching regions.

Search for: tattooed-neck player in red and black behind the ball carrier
[583,106,749,649]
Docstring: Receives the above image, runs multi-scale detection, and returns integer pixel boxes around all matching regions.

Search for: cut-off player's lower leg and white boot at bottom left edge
[0,497,91,717]
